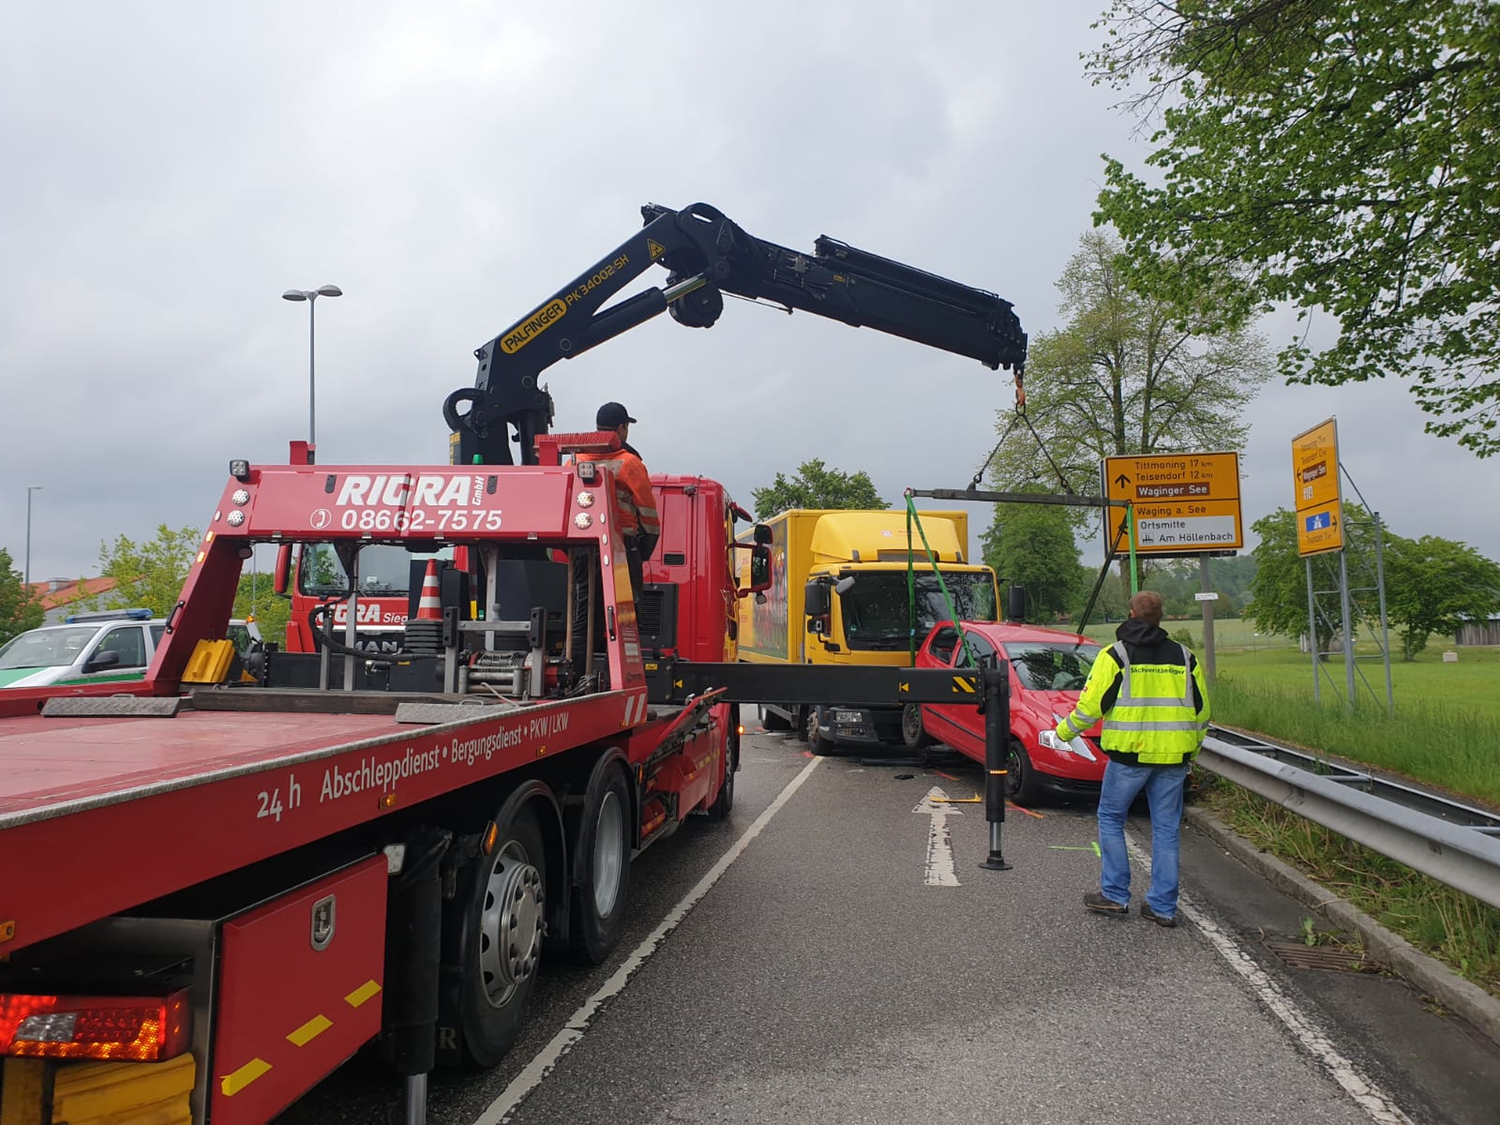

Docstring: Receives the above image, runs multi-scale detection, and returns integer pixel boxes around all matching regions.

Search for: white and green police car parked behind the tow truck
[0,609,261,689]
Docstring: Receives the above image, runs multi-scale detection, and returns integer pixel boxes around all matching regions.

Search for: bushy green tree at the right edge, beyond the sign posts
[1386,536,1500,660]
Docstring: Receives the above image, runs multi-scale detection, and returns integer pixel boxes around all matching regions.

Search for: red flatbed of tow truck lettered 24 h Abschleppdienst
[0,692,690,951]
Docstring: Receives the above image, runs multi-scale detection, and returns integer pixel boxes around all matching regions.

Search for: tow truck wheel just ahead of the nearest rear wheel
[572,767,630,965]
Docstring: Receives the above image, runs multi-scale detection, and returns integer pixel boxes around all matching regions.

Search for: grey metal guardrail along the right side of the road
[1199,728,1500,908]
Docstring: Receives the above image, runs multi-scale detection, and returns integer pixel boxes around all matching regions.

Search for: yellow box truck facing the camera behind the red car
[740,509,999,755]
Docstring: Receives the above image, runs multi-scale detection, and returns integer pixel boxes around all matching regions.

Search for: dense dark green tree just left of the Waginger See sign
[981,489,1082,621]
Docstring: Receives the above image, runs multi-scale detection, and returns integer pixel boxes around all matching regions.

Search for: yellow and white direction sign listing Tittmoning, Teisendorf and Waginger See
[1104,453,1245,555]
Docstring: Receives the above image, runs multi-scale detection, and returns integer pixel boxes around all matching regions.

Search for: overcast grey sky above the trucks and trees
[0,0,1500,591]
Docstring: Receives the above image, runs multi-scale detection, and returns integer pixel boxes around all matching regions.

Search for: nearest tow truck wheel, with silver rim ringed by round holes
[459,806,548,1070]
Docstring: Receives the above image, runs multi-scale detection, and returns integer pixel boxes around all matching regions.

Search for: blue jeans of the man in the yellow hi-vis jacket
[1100,759,1188,918]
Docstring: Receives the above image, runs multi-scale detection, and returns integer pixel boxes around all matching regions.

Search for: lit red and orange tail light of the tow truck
[0,989,192,1062]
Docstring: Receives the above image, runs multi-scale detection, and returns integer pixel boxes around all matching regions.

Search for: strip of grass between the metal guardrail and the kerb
[1196,777,1500,998]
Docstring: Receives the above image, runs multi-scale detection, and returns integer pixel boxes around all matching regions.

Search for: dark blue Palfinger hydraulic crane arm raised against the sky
[443,203,1026,465]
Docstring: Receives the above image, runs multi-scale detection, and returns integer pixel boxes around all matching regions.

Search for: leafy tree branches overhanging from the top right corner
[1086,0,1500,456]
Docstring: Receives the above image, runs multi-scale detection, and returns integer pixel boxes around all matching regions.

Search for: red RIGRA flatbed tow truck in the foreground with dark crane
[0,206,1025,1125]
